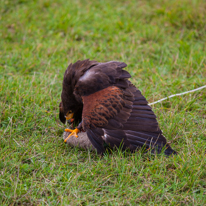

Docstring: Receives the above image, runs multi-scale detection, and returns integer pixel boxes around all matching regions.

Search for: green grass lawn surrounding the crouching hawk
[0,0,206,205]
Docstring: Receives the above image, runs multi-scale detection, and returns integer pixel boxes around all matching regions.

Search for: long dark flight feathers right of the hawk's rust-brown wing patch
[122,83,176,155]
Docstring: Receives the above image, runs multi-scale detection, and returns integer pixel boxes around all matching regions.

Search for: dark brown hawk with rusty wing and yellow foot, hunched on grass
[59,59,176,155]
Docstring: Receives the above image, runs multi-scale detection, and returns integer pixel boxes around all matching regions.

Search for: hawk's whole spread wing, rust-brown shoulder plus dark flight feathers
[82,82,175,155]
